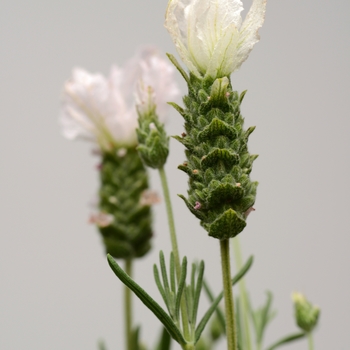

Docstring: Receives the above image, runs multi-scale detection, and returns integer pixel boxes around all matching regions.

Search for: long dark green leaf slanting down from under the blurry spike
[107,254,186,345]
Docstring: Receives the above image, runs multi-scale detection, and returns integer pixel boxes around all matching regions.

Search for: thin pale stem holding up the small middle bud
[159,167,191,342]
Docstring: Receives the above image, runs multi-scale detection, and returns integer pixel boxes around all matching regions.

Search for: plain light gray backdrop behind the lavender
[0,0,350,350]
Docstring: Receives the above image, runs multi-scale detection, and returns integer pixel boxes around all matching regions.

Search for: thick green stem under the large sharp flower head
[220,239,237,350]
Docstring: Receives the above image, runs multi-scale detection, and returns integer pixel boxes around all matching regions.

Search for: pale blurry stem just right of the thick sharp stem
[232,237,252,350]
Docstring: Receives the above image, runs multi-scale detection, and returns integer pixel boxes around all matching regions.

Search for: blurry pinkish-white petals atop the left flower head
[60,48,178,151]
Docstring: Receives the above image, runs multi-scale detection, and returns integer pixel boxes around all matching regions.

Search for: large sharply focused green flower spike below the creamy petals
[172,71,258,240]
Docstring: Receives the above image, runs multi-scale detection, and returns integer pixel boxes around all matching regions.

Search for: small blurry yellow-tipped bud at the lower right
[292,293,320,332]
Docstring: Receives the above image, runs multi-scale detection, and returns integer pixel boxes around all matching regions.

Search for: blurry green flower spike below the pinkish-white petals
[92,148,154,259]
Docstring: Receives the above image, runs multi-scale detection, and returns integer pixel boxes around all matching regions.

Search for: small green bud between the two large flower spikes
[136,108,169,169]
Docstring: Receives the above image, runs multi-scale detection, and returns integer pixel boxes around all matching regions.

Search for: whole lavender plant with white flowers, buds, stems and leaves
[61,0,319,350]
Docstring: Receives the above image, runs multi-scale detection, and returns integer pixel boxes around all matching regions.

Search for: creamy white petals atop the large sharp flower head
[165,0,266,79]
